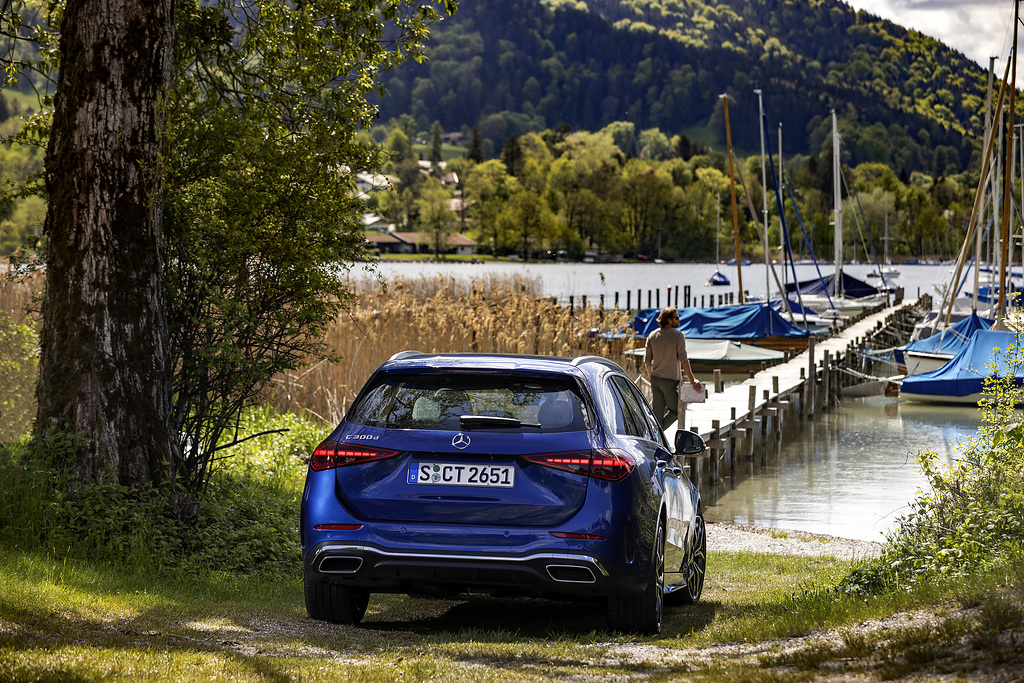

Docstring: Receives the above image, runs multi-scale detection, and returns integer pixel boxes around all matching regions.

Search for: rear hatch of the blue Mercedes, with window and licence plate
[322,373,591,526]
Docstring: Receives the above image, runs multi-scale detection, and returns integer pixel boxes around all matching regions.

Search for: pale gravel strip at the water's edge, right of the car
[708,522,885,560]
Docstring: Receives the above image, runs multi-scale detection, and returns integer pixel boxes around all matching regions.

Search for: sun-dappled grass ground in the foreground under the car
[0,544,1024,681]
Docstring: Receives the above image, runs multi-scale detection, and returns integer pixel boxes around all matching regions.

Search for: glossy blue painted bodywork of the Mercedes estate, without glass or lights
[300,355,698,626]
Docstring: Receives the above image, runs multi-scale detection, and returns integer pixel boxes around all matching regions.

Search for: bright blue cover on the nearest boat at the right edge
[900,330,1024,398]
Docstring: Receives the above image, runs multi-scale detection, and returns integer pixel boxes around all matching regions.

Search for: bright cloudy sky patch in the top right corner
[845,0,1024,67]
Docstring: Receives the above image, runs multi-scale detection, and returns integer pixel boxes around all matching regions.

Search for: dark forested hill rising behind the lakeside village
[381,0,987,175]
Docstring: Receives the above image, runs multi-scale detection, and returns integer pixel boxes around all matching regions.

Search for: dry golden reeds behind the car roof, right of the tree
[268,276,630,426]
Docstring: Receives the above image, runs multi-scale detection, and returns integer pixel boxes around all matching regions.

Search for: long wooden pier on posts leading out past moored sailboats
[665,303,920,482]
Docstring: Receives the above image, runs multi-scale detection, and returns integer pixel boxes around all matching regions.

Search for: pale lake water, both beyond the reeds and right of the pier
[362,262,981,541]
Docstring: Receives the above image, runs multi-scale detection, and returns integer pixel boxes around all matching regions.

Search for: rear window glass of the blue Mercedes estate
[347,373,587,432]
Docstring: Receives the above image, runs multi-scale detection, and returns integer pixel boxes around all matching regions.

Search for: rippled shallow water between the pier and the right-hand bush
[705,396,981,541]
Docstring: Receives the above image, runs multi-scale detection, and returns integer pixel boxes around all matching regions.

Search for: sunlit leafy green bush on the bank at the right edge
[843,348,1024,591]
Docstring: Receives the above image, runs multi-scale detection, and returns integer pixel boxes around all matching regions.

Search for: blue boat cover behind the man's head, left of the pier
[633,303,810,341]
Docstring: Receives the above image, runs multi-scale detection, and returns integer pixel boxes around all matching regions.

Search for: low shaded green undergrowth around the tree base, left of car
[0,410,322,574]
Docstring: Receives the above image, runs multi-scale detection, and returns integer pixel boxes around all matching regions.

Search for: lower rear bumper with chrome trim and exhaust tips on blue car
[304,541,642,596]
